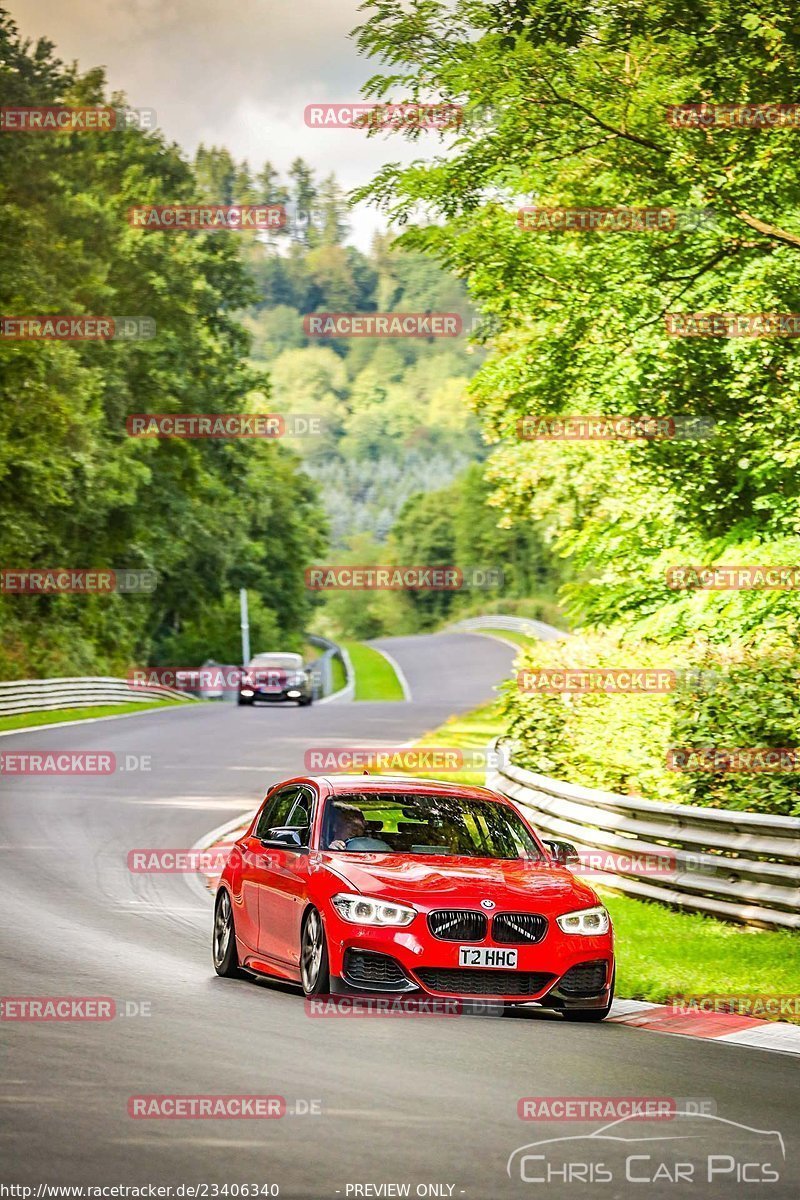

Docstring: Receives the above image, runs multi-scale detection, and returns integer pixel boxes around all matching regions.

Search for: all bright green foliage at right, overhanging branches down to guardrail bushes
[356,0,800,811]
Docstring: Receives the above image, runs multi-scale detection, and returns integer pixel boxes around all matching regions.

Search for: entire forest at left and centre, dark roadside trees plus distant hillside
[0,17,561,678]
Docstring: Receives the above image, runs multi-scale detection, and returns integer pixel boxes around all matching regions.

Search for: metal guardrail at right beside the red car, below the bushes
[486,743,800,929]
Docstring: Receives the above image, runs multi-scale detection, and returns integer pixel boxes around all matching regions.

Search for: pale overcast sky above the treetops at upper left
[7,0,439,248]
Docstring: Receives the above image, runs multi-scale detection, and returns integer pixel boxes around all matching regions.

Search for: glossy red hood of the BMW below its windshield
[324,853,599,913]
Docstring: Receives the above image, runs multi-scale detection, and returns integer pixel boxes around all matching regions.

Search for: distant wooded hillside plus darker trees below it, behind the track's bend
[188,146,563,637]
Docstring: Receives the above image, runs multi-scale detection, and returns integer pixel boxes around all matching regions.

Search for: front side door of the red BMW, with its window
[259,786,315,967]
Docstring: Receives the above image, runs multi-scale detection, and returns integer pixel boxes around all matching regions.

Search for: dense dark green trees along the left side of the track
[0,12,326,679]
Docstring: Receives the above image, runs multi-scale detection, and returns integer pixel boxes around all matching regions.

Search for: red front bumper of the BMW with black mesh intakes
[326,913,614,1009]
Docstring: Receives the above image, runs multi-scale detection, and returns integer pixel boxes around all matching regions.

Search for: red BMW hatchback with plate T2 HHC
[213,775,614,1021]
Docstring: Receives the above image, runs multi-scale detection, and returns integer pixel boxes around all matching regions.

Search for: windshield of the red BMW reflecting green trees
[321,792,543,859]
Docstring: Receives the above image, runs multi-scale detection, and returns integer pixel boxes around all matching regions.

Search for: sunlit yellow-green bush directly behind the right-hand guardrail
[503,634,800,815]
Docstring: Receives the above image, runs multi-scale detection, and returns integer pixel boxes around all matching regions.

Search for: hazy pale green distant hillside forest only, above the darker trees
[194,146,482,550]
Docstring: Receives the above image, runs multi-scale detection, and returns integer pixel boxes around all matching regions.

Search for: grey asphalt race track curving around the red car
[0,635,800,1200]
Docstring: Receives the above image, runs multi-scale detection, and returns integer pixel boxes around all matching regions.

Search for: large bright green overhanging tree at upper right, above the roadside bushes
[356,0,800,633]
